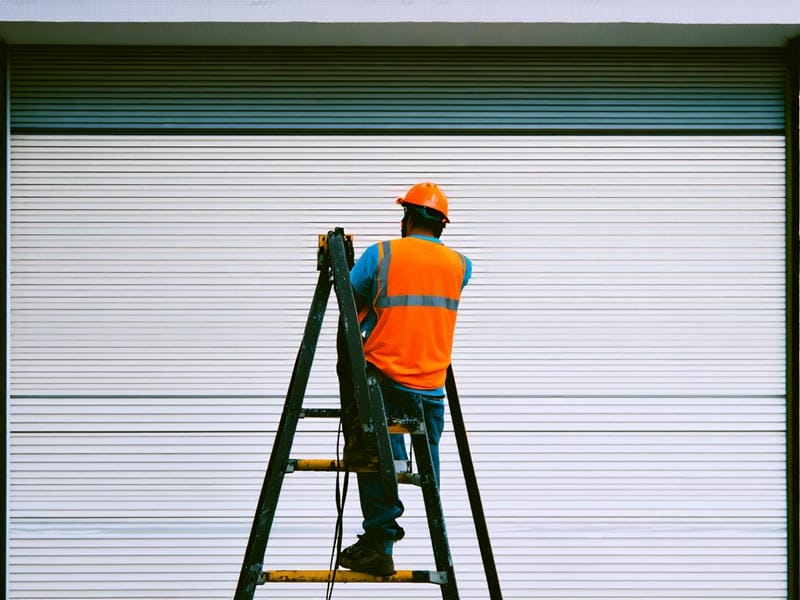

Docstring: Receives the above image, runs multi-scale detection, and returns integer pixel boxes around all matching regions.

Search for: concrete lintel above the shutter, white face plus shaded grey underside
[0,0,800,47]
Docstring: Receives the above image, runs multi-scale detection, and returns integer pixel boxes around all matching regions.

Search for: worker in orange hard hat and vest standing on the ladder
[339,183,472,576]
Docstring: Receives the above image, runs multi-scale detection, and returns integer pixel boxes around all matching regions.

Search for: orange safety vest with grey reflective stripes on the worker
[364,237,467,390]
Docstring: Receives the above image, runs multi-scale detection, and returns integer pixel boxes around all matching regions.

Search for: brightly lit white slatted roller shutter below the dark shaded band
[8,134,786,600]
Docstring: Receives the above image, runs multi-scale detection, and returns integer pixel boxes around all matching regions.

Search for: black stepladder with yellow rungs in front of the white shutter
[234,228,502,600]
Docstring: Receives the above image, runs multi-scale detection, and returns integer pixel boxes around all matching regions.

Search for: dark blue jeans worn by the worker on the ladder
[358,384,444,540]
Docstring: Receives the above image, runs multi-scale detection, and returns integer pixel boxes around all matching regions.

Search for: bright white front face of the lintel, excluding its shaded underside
[0,0,800,25]
